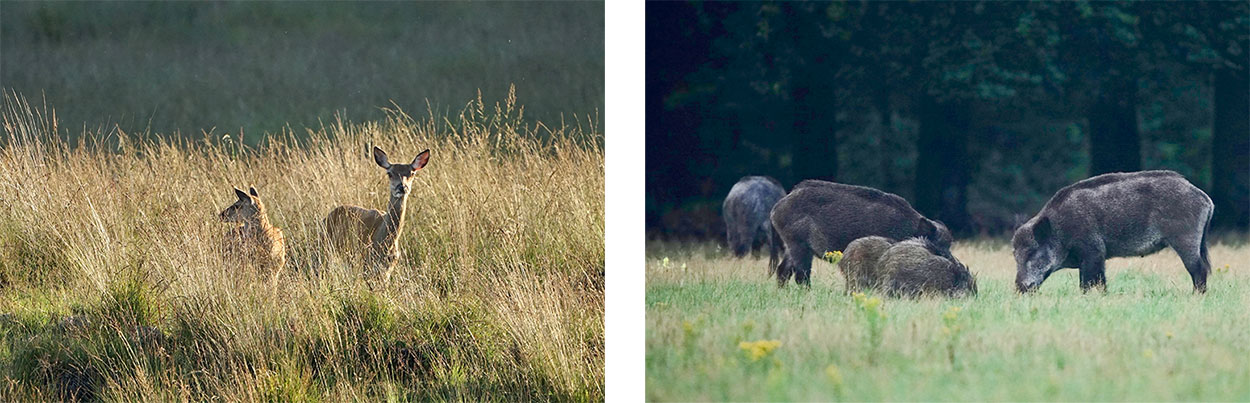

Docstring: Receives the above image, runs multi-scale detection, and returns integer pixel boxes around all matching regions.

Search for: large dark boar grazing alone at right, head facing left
[1011,170,1215,293]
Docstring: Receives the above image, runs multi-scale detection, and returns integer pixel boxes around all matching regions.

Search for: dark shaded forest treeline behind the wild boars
[646,1,1250,238]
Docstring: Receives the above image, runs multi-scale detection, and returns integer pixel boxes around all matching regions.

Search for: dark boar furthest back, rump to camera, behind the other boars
[721,176,785,274]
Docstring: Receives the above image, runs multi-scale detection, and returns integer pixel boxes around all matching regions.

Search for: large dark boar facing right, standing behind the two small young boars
[773,180,951,285]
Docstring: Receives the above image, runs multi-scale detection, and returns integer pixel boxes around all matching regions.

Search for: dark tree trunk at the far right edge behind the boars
[1211,69,1250,230]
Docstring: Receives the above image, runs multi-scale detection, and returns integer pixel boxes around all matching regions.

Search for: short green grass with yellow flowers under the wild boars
[646,243,1250,400]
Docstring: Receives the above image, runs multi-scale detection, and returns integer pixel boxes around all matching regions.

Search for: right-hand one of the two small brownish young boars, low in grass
[878,238,976,298]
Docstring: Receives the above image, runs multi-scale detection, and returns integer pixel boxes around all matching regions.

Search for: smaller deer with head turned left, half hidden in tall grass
[219,186,286,280]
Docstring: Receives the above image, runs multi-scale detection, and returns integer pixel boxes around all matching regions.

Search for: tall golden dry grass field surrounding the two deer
[0,92,604,402]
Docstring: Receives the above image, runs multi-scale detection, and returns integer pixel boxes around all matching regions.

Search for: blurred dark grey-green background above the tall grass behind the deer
[0,1,604,144]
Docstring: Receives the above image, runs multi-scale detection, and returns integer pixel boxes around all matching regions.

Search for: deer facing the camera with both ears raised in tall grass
[325,146,430,279]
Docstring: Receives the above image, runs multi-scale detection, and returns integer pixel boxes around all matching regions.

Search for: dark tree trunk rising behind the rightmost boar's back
[1088,76,1141,176]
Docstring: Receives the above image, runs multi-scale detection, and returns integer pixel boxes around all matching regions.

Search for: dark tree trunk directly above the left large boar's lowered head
[915,98,971,234]
